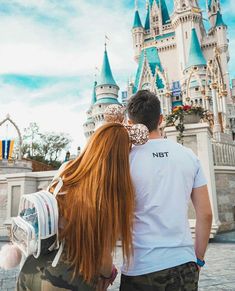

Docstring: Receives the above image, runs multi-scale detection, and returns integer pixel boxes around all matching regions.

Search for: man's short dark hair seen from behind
[127,90,161,132]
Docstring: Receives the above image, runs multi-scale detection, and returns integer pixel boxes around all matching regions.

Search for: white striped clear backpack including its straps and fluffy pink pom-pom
[0,170,64,269]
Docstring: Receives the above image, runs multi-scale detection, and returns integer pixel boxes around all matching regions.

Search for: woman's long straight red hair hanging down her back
[53,123,134,282]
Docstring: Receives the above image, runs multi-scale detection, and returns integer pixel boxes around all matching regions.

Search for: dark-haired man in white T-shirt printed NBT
[120,90,212,291]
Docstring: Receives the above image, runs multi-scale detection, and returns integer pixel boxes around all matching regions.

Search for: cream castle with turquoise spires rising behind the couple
[84,0,235,140]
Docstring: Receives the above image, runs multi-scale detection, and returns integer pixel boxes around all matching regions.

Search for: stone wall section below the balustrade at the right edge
[215,166,235,232]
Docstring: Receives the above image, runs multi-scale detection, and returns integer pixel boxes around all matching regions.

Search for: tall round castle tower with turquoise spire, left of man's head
[92,44,120,129]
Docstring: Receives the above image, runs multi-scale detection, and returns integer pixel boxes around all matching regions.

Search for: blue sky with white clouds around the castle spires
[0,0,235,160]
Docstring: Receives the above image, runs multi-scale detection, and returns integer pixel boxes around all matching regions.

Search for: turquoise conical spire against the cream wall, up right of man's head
[186,28,206,68]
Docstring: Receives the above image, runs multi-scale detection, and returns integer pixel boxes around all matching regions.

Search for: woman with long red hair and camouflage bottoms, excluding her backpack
[17,123,134,291]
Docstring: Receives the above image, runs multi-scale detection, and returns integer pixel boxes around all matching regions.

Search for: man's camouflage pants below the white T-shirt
[119,262,199,291]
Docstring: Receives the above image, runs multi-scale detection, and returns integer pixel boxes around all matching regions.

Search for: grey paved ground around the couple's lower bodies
[0,243,235,291]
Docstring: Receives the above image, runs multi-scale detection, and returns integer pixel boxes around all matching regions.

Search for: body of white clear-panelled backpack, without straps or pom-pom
[11,181,62,258]
